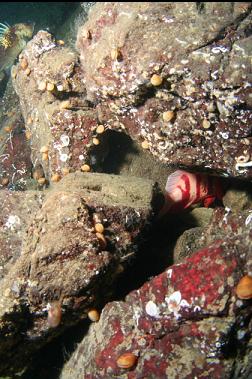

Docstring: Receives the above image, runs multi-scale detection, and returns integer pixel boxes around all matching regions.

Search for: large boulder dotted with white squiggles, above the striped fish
[76,2,252,178]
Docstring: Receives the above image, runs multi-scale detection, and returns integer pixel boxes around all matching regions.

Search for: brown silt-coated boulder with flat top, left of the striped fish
[0,173,158,375]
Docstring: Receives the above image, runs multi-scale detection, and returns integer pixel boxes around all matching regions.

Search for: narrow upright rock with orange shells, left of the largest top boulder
[12,31,106,182]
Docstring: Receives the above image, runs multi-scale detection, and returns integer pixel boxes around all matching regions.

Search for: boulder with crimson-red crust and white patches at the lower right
[61,211,252,379]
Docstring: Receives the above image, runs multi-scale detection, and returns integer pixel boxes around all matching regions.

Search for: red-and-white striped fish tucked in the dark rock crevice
[159,170,223,216]
